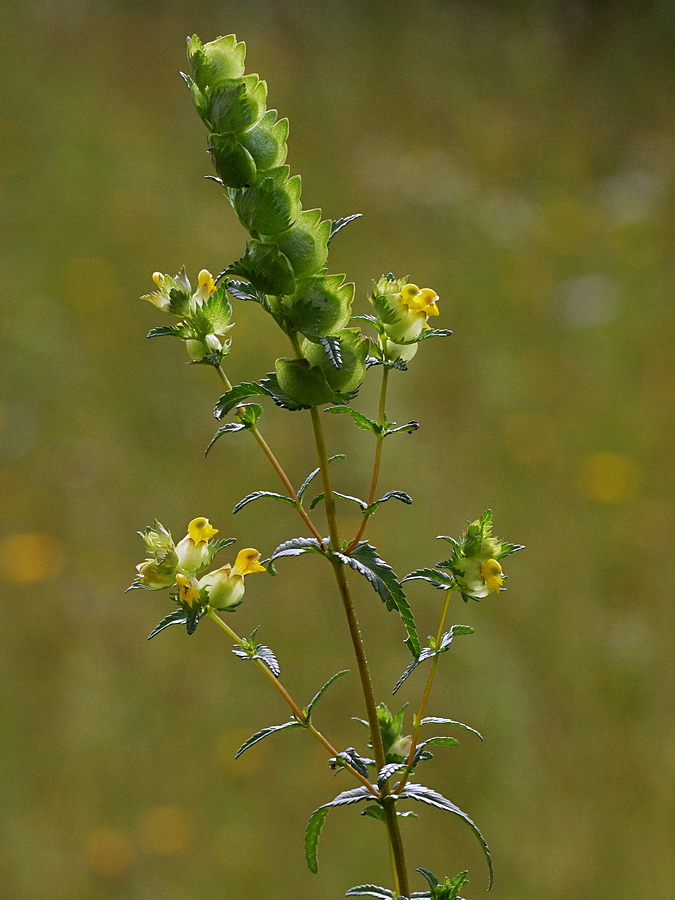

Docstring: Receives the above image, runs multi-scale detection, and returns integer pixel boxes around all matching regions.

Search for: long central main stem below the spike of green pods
[310,407,410,897]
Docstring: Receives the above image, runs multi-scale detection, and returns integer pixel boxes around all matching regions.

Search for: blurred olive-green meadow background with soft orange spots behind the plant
[0,0,675,900]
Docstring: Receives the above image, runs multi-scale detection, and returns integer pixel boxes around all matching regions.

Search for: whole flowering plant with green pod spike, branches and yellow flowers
[131,35,521,900]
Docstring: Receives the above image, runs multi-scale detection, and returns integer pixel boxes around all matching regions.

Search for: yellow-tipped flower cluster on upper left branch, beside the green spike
[142,269,234,365]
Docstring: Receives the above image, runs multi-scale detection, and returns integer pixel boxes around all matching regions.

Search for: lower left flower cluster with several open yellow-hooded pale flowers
[131,517,265,611]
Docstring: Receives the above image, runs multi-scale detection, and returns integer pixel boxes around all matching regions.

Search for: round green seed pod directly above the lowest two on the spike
[284,275,354,341]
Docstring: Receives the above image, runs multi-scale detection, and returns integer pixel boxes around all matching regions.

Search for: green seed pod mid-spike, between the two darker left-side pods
[233,166,302,236]
